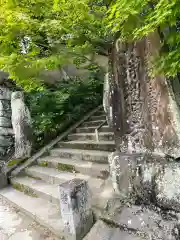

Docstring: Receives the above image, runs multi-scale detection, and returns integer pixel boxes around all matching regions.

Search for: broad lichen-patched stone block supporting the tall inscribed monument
[109,152,180,212]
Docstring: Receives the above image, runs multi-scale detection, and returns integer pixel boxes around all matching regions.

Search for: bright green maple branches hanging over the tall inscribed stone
[106,0,180,77]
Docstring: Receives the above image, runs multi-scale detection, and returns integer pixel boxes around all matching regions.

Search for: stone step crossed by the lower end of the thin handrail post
[68,132,114,141]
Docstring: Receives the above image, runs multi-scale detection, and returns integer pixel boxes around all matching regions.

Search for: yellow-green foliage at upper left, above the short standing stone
[0,0,108,91]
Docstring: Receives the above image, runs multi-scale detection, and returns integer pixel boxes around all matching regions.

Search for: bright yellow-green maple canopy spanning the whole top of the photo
[0,0,180,90]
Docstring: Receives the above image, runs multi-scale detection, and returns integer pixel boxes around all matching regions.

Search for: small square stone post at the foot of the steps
[59,179,93,240]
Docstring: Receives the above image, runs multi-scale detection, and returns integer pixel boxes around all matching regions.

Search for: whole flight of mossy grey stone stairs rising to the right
[0,109,115,238]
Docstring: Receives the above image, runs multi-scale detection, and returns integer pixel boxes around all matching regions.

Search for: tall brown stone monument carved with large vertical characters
[110,33,180,158]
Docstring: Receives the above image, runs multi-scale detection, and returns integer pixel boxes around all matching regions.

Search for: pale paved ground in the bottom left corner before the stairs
[0,197,58,240]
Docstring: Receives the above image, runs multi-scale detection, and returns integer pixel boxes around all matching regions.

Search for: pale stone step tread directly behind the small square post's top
[25,166,104,194]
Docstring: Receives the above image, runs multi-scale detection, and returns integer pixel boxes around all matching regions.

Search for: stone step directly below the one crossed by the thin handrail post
[57,141,115,152]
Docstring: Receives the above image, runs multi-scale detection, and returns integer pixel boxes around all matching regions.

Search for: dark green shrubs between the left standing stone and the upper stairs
[26,75,103,151]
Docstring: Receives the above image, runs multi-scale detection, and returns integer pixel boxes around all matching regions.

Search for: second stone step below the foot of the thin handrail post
[50,148,111,163]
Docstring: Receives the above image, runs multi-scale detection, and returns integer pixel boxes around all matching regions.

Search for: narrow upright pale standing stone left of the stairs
[11,91,32,158]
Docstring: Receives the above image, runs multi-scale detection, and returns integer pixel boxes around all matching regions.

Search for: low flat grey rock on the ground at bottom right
[105,206,180,240]
